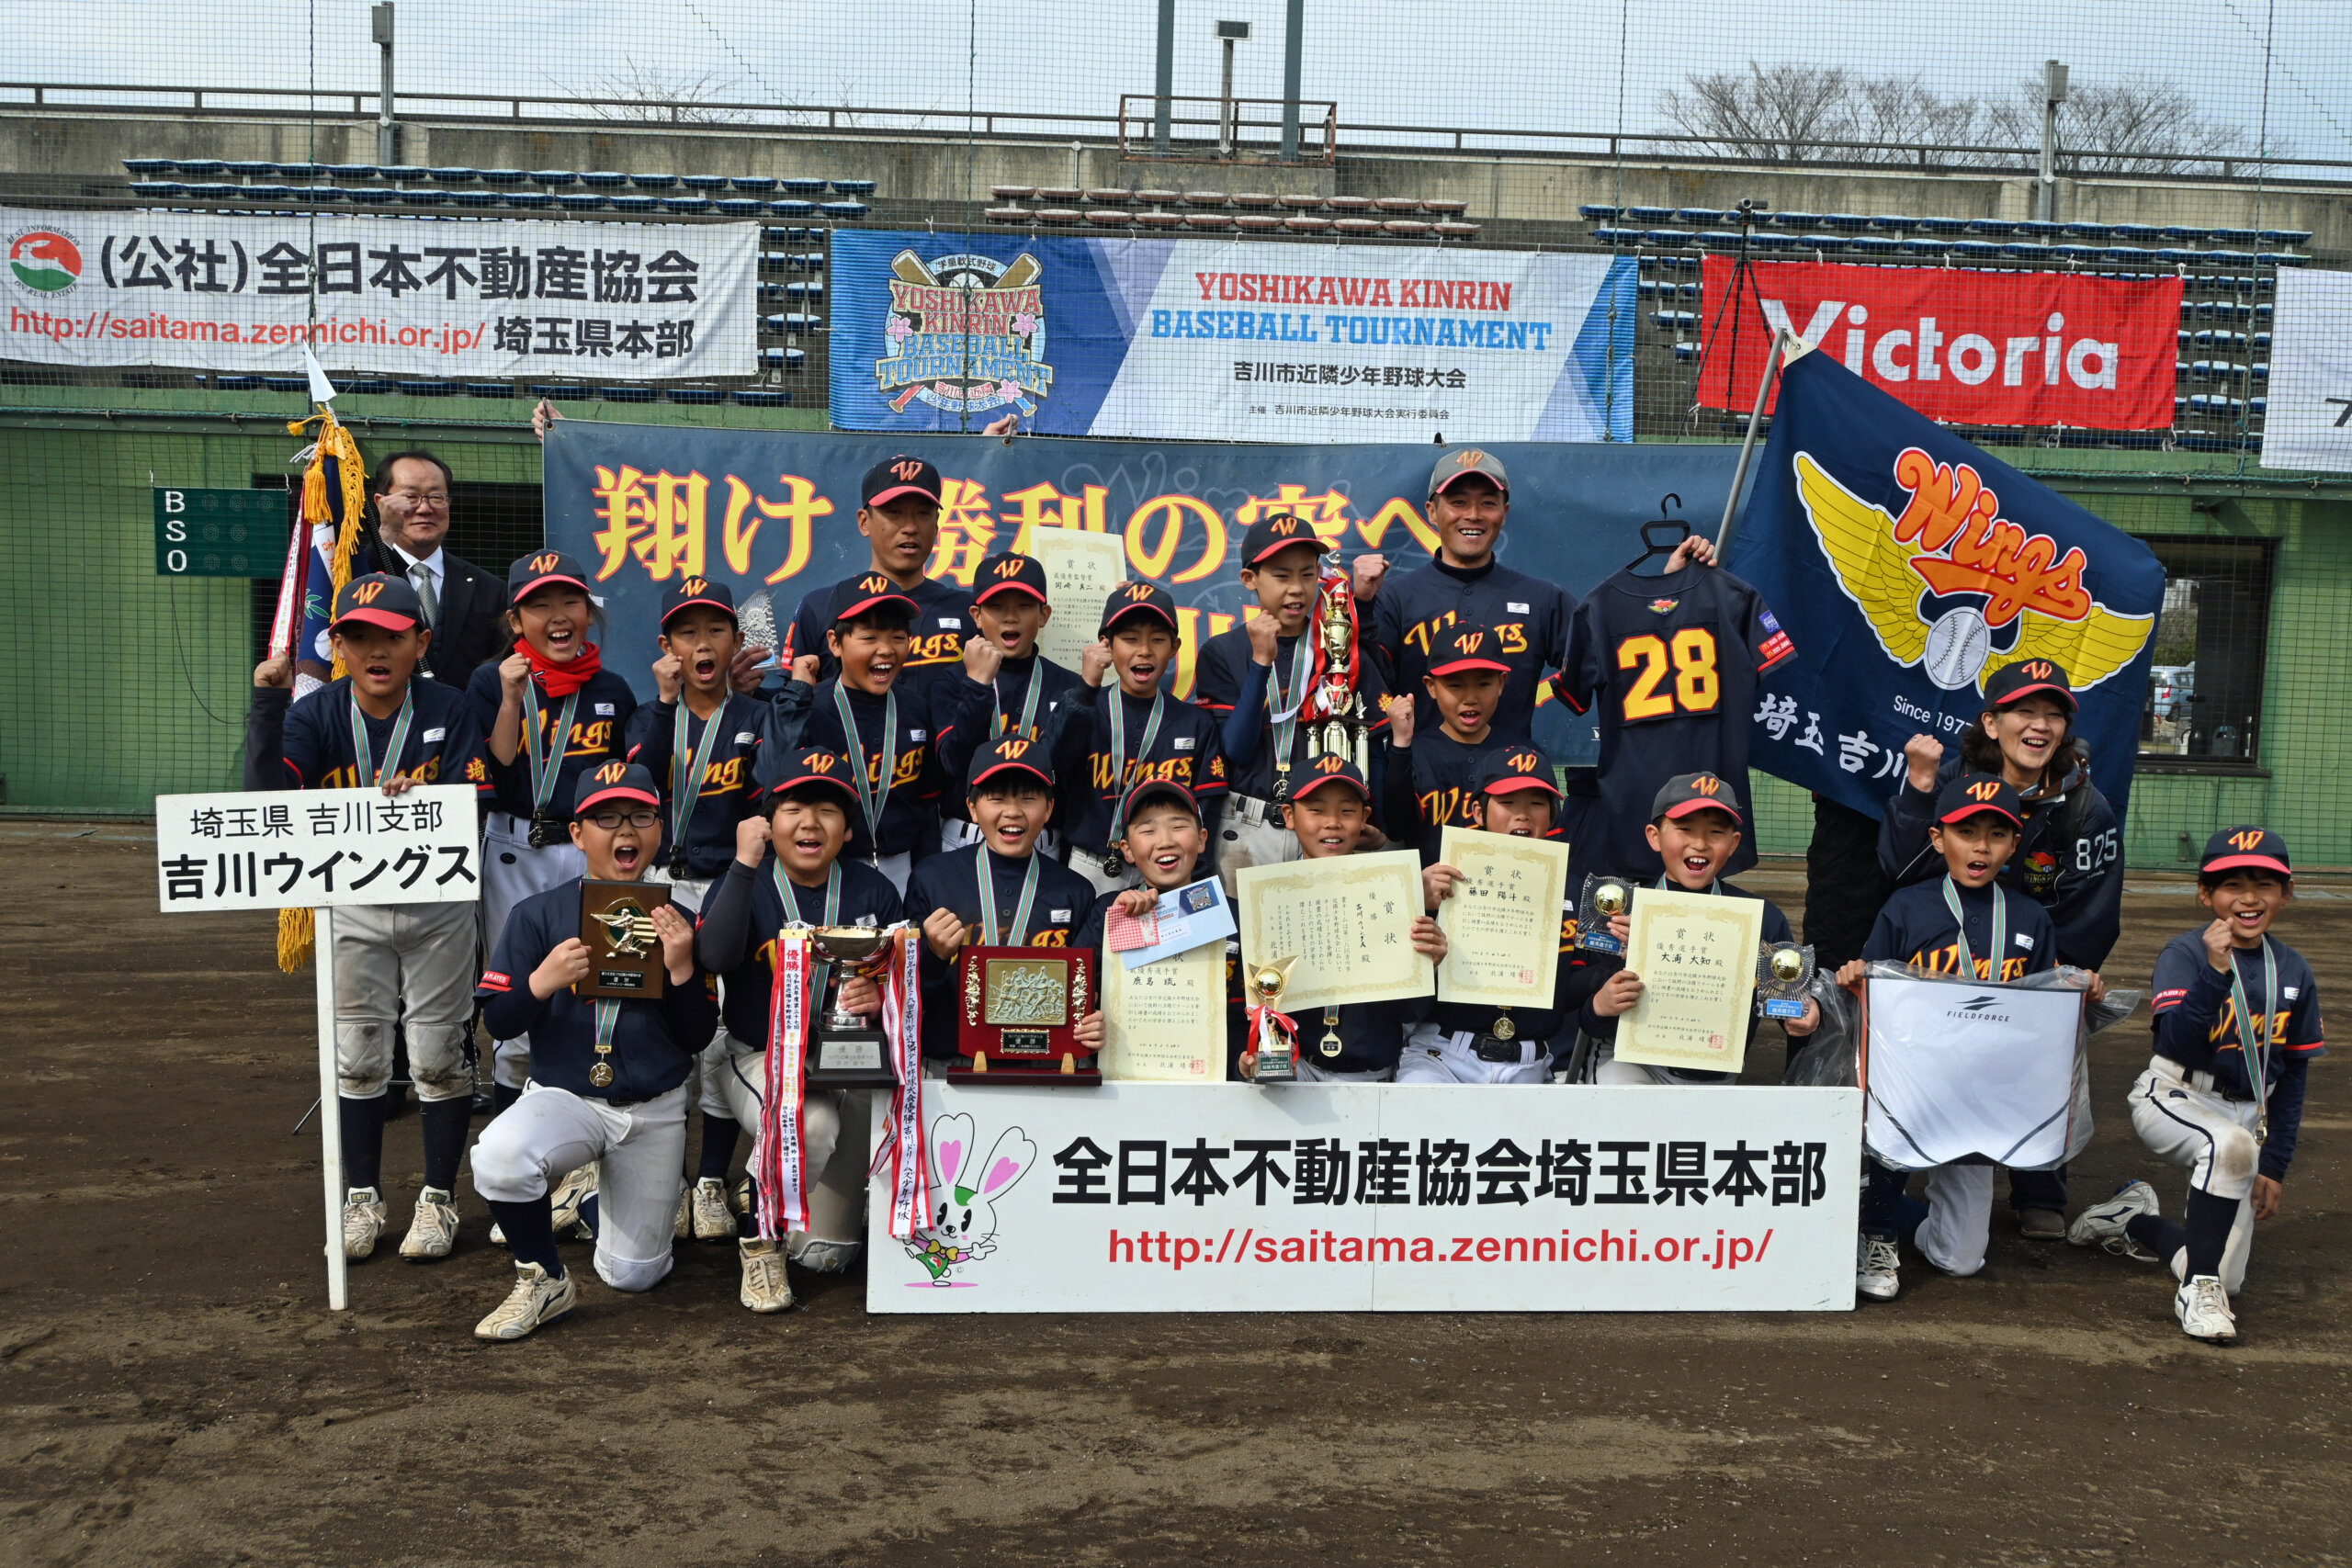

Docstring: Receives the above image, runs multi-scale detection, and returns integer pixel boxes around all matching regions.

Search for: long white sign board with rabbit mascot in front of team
[865,1084,1863,1312]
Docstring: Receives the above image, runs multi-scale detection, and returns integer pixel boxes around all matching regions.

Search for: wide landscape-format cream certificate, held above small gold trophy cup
[1235,849,1437,1010]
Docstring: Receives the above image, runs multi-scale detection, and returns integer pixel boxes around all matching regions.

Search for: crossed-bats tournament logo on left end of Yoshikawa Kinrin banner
[875,249,1054,419]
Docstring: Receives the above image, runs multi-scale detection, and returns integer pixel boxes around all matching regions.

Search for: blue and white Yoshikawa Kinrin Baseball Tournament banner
[831,231,1634,442]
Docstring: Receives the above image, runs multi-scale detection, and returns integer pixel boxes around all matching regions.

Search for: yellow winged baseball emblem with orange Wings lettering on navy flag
[1794,446,2157,691]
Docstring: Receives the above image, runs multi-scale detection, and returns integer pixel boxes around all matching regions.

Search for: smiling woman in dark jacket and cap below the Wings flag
[1879,659,2124,1241]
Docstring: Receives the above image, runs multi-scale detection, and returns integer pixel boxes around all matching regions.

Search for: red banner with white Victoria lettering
[1698,256,2180,430]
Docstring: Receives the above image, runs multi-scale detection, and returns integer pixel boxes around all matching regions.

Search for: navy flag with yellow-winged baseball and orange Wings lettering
[1724,353,2164,816]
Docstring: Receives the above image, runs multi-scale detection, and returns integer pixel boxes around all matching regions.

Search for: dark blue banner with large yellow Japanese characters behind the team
[546,419,1738,761]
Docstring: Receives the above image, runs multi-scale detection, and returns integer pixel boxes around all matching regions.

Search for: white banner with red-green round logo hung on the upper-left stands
[0,209,760,381]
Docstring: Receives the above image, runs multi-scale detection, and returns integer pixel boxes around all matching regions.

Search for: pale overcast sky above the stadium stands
[0,0,2352,160]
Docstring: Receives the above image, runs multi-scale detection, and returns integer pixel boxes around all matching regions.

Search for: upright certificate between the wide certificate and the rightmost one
[1437,825,1569,1009]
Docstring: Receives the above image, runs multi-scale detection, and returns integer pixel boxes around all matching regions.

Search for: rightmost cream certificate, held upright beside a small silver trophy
[1616,888,1764,1072]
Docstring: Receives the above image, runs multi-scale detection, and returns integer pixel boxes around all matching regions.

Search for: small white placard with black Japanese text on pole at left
[155,785,482,915]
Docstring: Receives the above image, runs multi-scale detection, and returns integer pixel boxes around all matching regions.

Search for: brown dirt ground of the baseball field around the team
[0,820,2352,1568]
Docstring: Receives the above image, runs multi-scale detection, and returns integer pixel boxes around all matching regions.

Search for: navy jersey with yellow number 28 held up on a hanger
[1553,567,1797,879]
